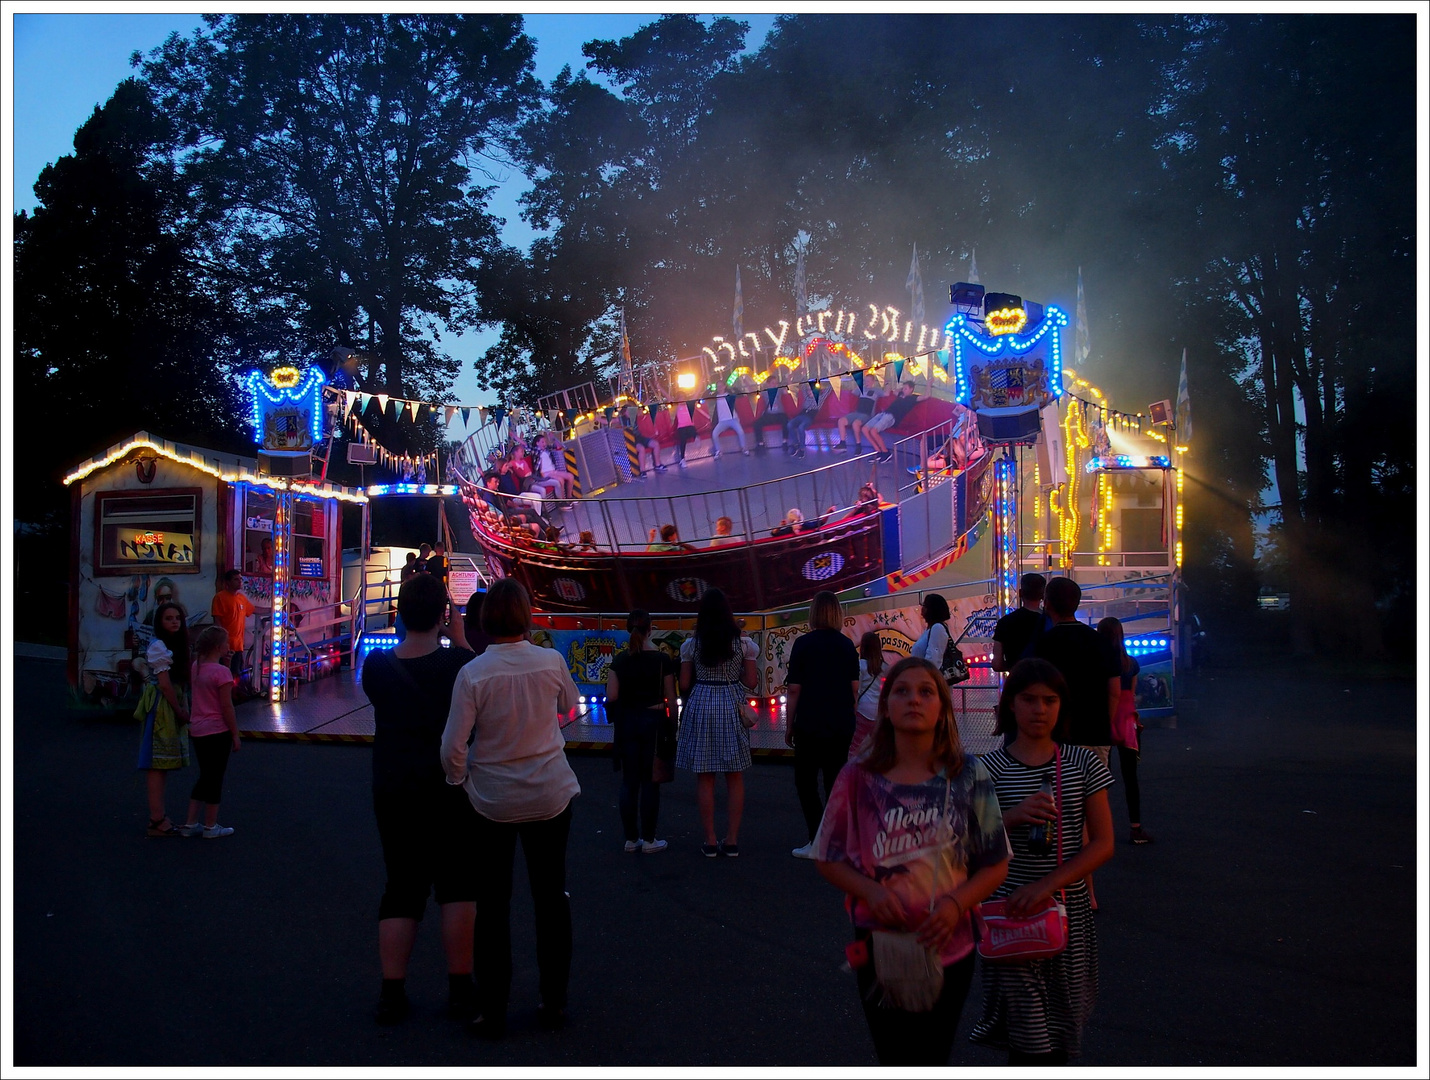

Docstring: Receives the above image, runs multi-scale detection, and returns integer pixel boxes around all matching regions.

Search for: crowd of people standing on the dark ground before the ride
[136,545,1151,1064]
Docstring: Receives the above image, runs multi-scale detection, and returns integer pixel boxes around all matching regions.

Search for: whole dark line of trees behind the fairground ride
[16,16,1414,654]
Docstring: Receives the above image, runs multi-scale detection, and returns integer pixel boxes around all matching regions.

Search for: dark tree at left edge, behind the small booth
[14,80,247,521]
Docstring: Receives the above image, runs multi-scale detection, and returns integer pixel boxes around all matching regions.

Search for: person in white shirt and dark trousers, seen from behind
[442,578,581,1037]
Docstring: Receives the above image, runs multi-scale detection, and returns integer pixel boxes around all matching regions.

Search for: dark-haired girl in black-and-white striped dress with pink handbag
[971,659,1113,1064]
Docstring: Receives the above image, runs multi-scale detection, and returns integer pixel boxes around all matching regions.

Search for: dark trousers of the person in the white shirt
[473,802,571,1021]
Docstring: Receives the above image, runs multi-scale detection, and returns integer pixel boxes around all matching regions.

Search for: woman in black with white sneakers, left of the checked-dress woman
[606,611,676,855]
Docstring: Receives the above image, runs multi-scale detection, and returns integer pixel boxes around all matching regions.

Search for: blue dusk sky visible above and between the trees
[10,13,775,405]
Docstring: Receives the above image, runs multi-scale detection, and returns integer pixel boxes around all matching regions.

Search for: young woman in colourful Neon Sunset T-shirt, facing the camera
[814,657,1008,1066]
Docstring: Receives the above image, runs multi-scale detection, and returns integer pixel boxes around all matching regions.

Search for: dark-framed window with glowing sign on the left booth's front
[94,488,203,575]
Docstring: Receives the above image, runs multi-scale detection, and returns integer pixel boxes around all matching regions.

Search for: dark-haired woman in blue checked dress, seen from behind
[675,589,759,858]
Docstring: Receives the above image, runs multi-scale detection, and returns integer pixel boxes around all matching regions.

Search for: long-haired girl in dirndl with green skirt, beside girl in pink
[134,604,189,837]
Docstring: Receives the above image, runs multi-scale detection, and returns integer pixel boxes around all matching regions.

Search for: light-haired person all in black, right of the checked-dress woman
[785,589,859,858]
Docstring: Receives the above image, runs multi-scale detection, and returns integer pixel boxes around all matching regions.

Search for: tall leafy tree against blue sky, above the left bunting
[136,14,536,395]
